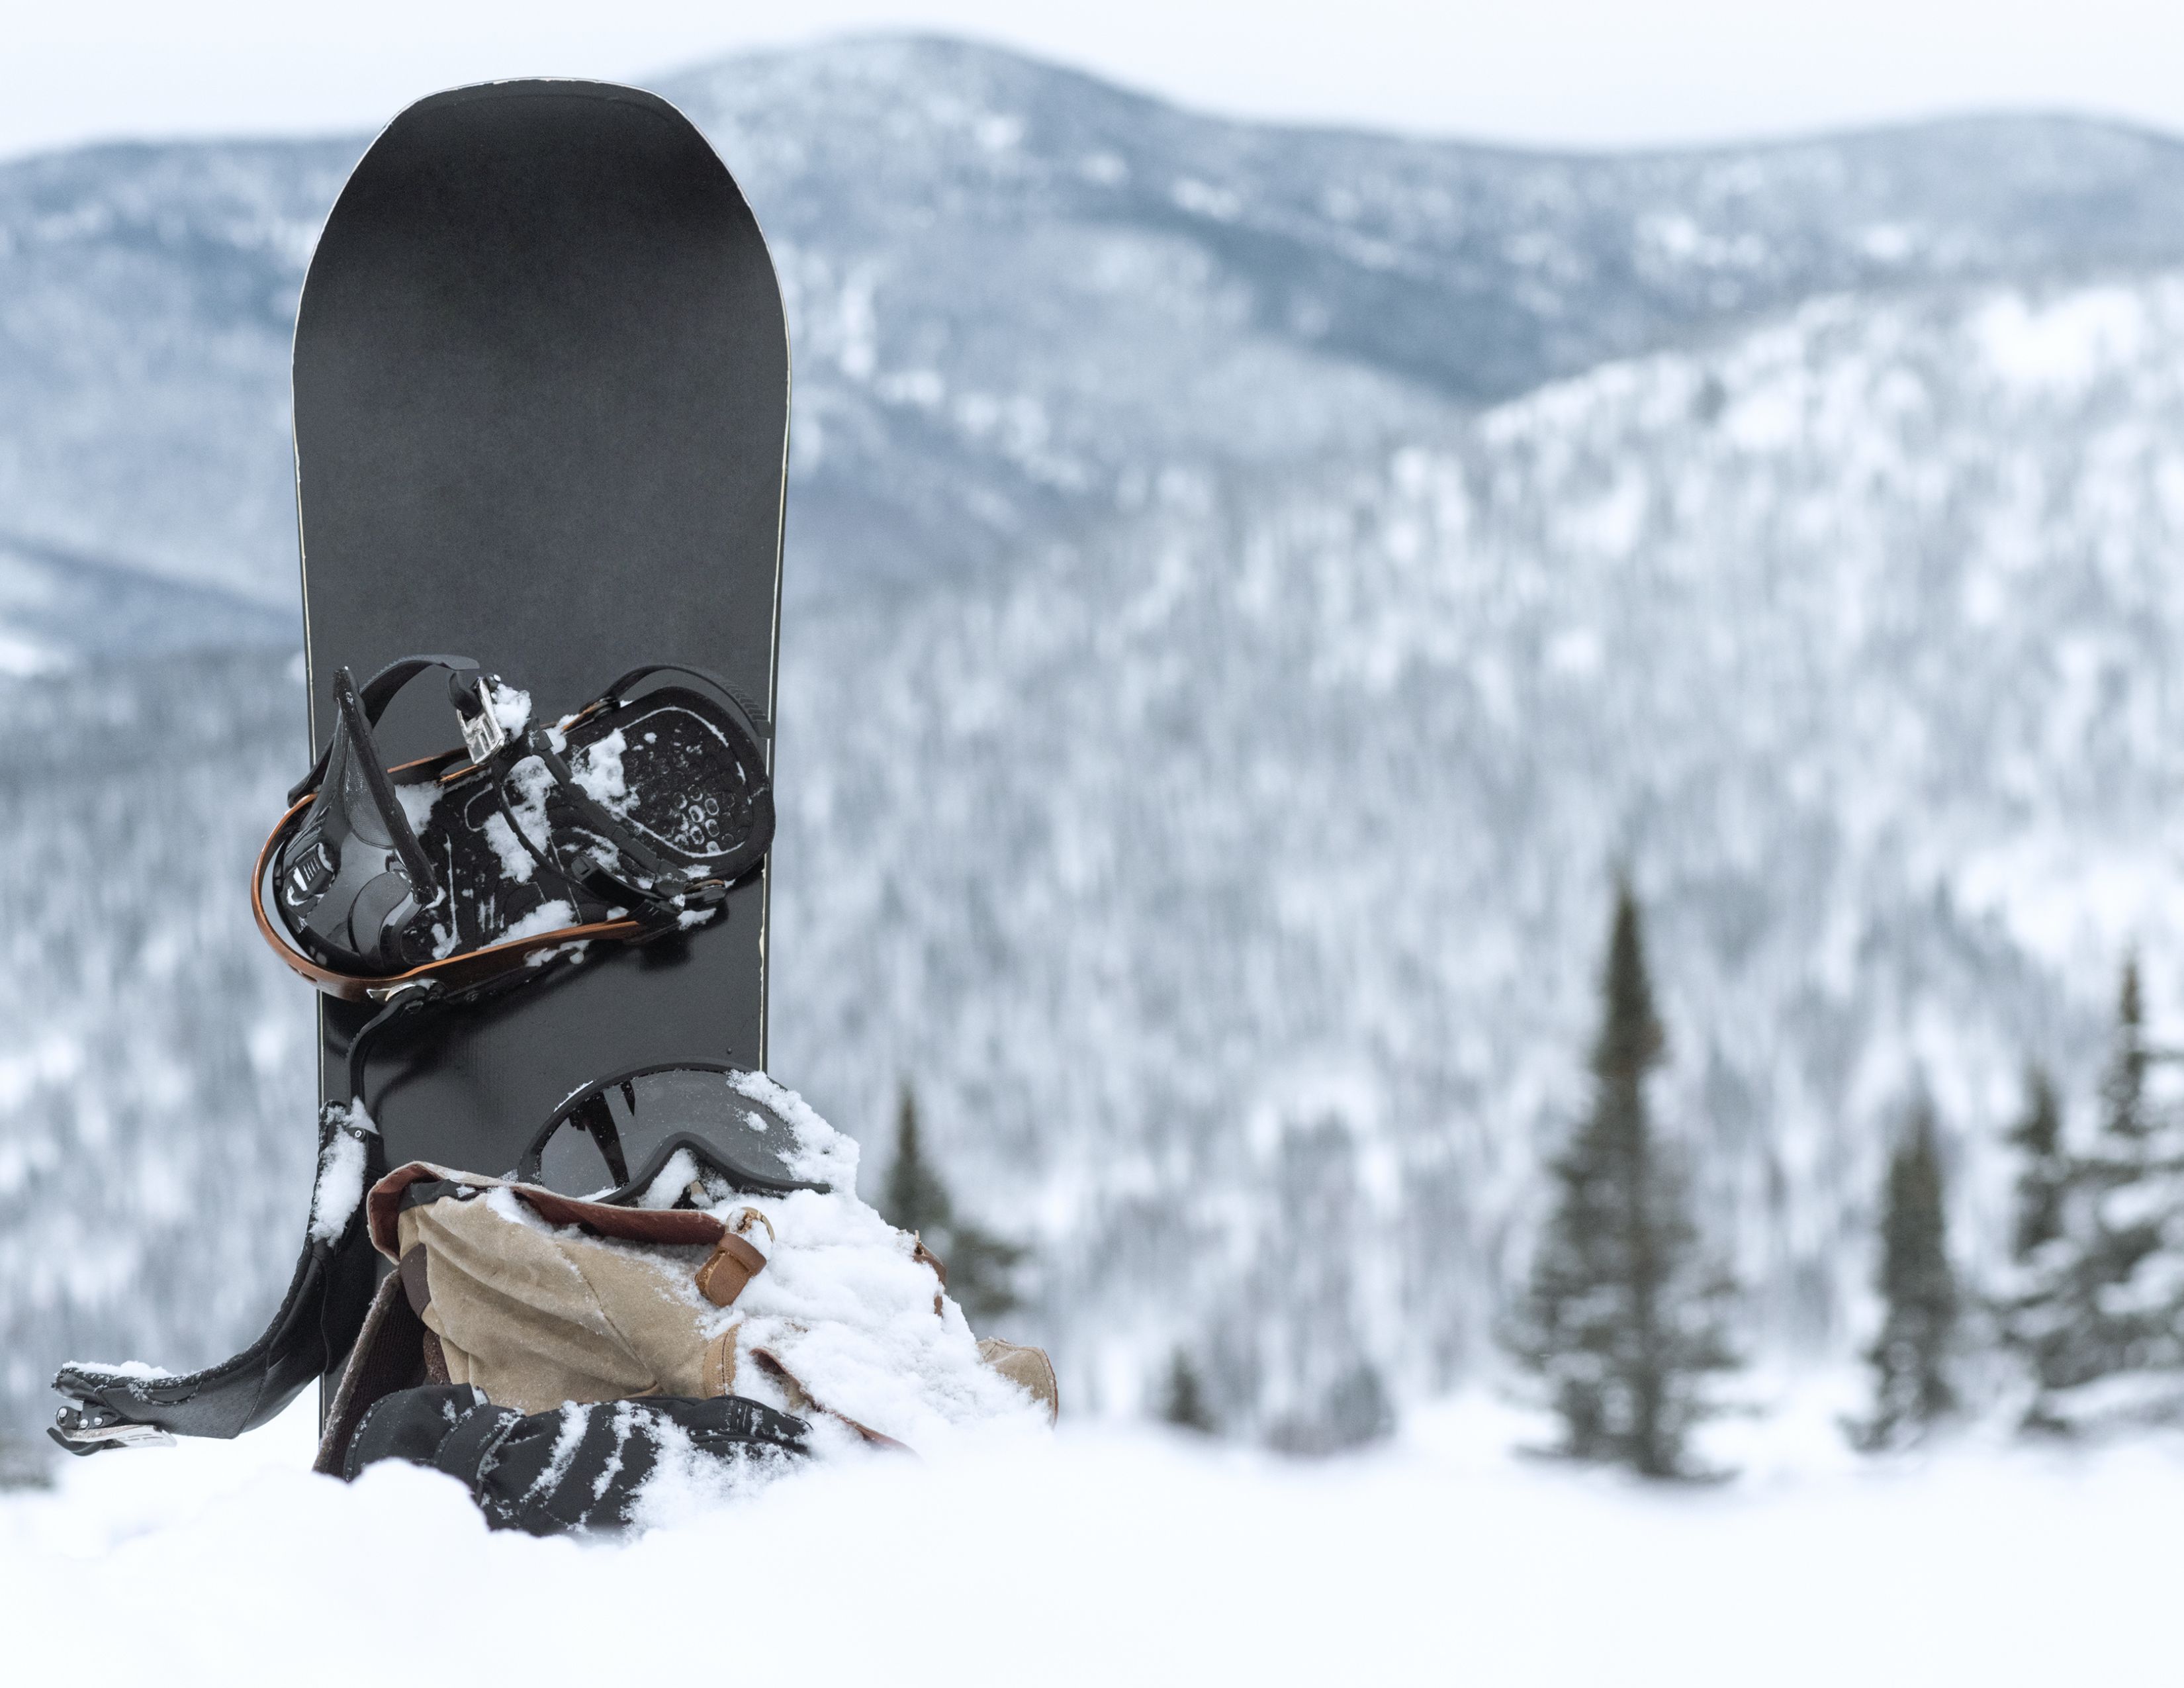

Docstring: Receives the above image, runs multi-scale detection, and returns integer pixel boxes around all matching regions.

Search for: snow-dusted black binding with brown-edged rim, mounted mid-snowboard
[251,657,773,1002]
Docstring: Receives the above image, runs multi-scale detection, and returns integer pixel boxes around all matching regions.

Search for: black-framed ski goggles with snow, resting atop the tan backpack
[516,1061,828,1203]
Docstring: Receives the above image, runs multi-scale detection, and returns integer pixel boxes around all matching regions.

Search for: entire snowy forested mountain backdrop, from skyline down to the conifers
[0,42,2184,1432]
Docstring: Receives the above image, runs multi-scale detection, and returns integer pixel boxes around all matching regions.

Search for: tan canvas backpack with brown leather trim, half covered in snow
[319,1162,1060,1472]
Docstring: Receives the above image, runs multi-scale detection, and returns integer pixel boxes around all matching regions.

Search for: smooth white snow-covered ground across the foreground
[0,1397,2184,1688]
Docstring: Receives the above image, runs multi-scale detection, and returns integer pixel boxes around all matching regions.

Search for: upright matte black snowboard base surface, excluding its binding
[295,81,788,1175]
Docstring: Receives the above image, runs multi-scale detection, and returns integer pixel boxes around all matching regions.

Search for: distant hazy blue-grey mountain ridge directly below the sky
[13,39,2184,602]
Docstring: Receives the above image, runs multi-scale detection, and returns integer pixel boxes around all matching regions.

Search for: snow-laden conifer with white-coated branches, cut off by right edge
[2009,961,2184,1432]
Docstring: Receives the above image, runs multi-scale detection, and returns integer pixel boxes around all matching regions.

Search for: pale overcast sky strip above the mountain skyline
[0,0,2184,155]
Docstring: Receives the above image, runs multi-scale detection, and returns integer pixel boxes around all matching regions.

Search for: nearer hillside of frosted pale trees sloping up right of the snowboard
[780,277,2184,1411]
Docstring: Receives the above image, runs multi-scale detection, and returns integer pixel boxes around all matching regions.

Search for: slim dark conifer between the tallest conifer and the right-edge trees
[1856,1094,1957,1450]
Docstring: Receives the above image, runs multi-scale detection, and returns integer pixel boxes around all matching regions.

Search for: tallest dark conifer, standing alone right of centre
[1512,882,1734,1476]
